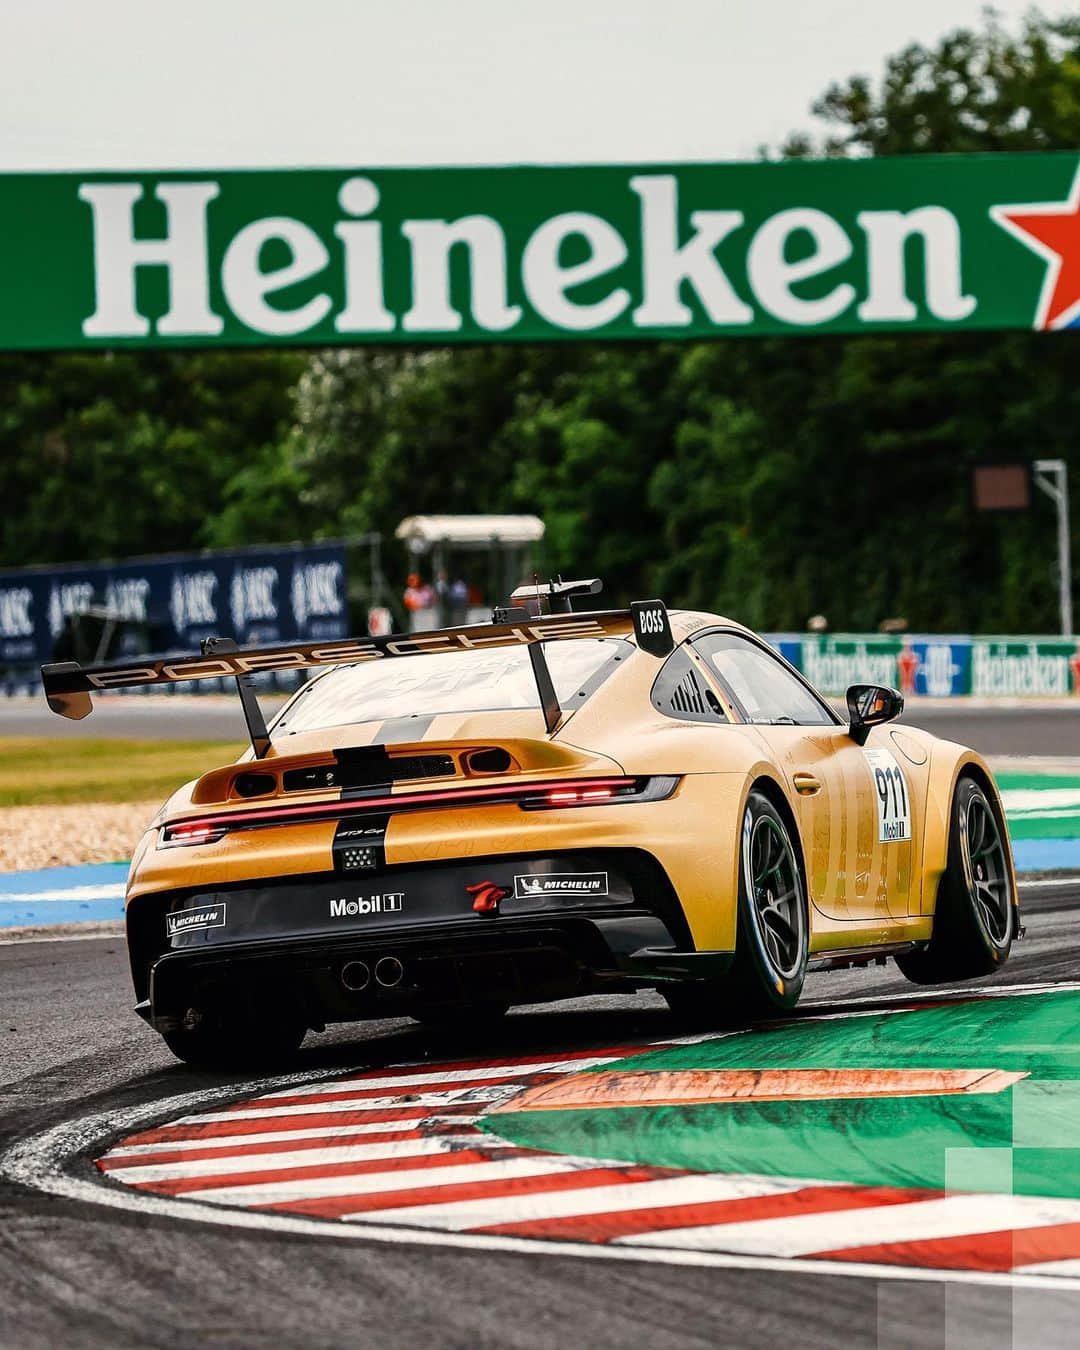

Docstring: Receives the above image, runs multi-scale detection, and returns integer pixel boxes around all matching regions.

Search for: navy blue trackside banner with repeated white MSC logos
[0,544,348,667]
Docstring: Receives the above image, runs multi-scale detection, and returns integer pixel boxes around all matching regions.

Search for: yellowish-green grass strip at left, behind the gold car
[0,736,243,807]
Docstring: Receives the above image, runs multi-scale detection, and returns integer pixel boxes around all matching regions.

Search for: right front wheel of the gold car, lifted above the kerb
[896,775,1017,984]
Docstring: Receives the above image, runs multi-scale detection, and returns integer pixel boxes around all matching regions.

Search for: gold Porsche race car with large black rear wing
[42,581,1018,1064]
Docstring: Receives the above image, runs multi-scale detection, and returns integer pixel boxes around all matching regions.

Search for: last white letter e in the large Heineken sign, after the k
[747,207,855,327]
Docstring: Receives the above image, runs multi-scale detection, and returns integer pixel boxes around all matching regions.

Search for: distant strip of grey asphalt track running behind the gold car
[0,695,1080,759]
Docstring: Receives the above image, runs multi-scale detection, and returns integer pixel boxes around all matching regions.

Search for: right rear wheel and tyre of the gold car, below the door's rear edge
[660,791,810,1026]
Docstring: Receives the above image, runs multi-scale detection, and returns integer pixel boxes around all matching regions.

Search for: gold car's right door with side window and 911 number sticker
[693,630,918,922]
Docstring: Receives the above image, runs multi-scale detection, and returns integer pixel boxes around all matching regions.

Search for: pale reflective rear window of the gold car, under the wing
[274,637,623,734]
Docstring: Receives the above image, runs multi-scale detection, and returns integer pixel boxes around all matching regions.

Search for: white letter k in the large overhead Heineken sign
[630,174,753,328]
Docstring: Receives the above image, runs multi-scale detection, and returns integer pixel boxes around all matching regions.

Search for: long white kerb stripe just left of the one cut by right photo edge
[344,1158,810,1233]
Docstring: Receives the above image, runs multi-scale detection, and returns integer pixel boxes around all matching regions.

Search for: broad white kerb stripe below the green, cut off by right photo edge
[616,1195,1080,1257]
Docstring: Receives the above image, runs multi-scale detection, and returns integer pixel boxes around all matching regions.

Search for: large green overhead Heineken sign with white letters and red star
[0,153,1080,350]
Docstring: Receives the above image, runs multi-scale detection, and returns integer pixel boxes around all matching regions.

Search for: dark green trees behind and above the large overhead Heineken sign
[0,12,1080,632]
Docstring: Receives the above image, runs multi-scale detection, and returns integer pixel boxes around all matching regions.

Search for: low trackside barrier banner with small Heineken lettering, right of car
[770,633,1080,698]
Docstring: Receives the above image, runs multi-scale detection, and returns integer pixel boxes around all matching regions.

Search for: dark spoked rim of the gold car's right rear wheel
[743,810,806,980]
